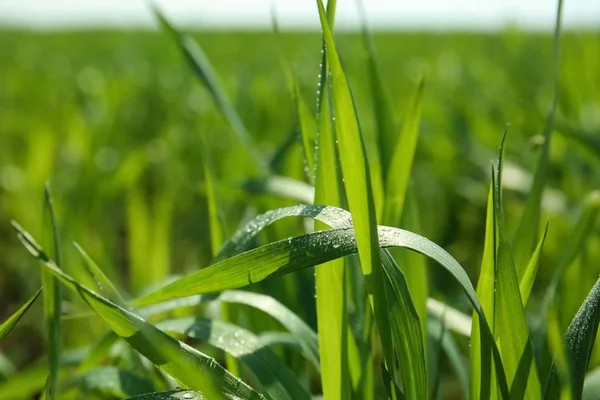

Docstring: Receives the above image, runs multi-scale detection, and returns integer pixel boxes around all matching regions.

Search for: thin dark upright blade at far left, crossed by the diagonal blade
[42,183,62,400]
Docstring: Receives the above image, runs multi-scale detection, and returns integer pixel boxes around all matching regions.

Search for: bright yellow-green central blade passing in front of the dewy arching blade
[317,0,404,398]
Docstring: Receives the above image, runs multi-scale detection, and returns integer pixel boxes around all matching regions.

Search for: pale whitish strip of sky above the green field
[0,0,600,30]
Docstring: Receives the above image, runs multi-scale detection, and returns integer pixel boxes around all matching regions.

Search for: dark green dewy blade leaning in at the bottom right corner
[545,279,600,400]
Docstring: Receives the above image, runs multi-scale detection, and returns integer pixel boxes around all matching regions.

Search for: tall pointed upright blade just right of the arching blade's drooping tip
[493,132,542,399]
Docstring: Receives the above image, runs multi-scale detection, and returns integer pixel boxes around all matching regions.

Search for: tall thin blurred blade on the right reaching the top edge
[512,0,563,281]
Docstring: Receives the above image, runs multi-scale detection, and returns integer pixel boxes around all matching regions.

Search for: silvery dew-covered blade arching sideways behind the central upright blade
[131,206,508,397]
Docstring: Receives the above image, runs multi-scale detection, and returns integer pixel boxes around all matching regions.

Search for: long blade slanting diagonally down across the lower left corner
[13,222,264,400]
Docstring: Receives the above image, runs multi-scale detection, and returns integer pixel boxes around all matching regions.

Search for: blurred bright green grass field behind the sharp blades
[0,25,600,398]
